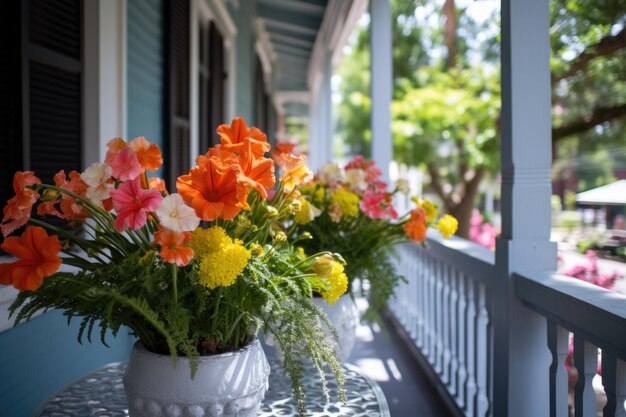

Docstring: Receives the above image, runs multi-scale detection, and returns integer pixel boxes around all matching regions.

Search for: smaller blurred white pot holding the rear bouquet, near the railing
[313,294,359,362]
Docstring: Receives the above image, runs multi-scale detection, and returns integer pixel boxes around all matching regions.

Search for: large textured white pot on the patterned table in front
[124,339,270,417]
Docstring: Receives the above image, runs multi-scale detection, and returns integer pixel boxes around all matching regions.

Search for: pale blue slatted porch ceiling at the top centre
[257,0,328,91]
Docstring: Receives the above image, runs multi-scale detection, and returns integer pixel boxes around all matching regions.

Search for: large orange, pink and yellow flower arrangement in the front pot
[0,118,343,414]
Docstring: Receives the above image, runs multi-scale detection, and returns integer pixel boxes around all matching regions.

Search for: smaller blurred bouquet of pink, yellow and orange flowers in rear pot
[278,156,458,319]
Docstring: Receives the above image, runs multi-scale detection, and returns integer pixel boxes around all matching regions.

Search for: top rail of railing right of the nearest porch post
[513,272,626,360]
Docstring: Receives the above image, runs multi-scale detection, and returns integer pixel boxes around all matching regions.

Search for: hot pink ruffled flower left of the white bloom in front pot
[111,178,163,232]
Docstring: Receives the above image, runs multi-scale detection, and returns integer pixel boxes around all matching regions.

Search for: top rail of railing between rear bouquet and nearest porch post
[403,230,495,287]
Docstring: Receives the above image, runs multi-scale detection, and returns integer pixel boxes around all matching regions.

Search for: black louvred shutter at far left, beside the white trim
[22,0,82,182]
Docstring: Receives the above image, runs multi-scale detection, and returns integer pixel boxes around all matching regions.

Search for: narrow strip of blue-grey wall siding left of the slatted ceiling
[226,0,256,124]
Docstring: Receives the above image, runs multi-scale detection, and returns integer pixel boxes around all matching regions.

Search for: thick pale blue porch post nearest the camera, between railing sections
[492,0,556,417]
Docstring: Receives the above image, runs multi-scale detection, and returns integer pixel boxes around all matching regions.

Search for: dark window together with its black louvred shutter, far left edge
[0,0,82,219]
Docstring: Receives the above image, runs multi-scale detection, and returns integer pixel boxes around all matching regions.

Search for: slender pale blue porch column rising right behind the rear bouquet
[370,0,393,181]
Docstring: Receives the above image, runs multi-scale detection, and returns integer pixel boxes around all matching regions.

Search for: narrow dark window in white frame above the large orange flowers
[198,22,228,154]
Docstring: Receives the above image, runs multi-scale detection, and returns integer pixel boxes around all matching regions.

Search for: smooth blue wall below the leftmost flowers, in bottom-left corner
[0,311,134,417]
